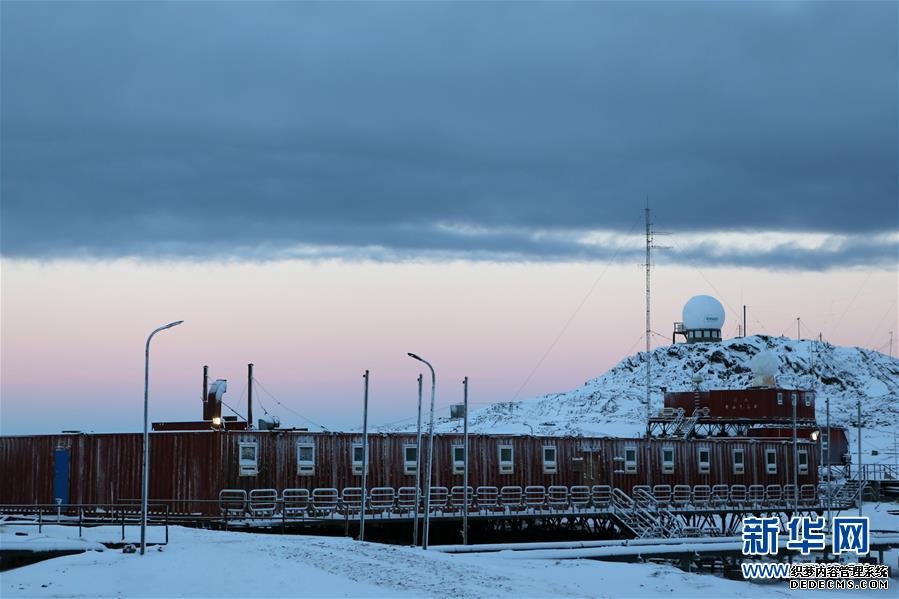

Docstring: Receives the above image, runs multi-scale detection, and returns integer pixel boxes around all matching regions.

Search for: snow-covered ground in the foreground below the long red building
[0,503,899,598]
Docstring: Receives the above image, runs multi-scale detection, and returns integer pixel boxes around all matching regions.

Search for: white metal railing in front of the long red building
[0,485,832,542]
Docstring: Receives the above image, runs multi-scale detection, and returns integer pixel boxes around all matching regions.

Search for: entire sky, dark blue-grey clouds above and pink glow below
[0,1,899,434]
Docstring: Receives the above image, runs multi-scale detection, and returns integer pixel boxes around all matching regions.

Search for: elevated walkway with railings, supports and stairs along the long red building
[0,485,844,539]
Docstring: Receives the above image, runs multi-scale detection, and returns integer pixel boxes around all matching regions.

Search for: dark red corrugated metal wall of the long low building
[0,431,818,504]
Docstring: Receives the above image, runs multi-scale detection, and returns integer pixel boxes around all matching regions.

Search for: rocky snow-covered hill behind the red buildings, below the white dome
[400,335,899,454]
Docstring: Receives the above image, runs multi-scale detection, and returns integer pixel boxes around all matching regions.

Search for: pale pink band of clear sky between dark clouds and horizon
[0,258,899,434]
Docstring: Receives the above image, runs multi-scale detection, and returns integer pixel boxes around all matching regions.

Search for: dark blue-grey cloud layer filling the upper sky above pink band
[0,2,899,268]
